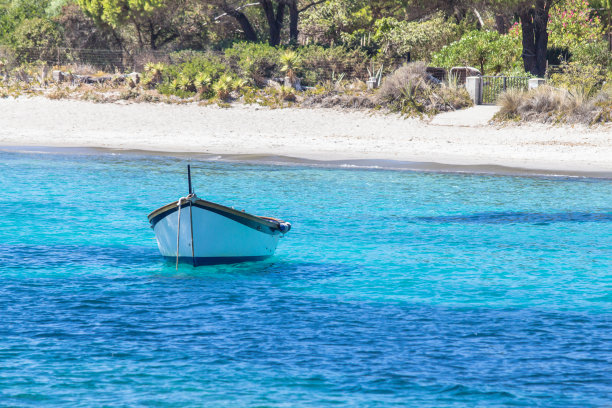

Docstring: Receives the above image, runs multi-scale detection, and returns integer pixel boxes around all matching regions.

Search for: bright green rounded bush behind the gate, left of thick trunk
[432,31,522,75]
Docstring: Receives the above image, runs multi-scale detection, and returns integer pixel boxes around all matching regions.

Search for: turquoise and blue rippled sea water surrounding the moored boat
[0,152,612,407]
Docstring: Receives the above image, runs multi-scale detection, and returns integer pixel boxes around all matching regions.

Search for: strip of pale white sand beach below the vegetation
[0,97,612,172]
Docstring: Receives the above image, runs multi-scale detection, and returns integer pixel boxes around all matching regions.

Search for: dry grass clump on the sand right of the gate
[495,86,612,124]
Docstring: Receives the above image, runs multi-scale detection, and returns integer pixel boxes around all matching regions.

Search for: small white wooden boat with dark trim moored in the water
[148,166,291,267]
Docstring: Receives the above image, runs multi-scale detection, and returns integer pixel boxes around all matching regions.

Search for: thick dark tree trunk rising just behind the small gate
[519,0,552,77]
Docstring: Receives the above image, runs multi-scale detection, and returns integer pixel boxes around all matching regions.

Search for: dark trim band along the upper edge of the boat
[149,200,280,235]
